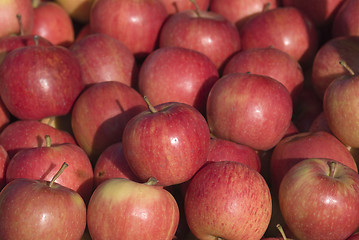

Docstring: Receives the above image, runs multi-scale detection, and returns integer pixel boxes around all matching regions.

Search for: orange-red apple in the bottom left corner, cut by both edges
[0,177,86,240]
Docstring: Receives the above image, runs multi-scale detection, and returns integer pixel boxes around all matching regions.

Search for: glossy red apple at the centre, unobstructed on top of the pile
[122,102,210,186]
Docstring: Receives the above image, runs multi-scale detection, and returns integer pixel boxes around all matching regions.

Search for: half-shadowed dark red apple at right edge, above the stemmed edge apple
[311,36,359,99]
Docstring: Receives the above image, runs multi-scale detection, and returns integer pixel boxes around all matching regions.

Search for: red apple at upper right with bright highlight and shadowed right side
[240,7,318,67]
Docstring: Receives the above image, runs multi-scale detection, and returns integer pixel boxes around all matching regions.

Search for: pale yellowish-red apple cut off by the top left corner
[0,0,34,37]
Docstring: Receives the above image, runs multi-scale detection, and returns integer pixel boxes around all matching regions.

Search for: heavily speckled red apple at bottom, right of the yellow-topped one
[184,161,272,240]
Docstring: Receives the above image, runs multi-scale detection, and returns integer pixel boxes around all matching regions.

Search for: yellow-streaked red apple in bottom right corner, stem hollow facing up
[279,158,359,240]
